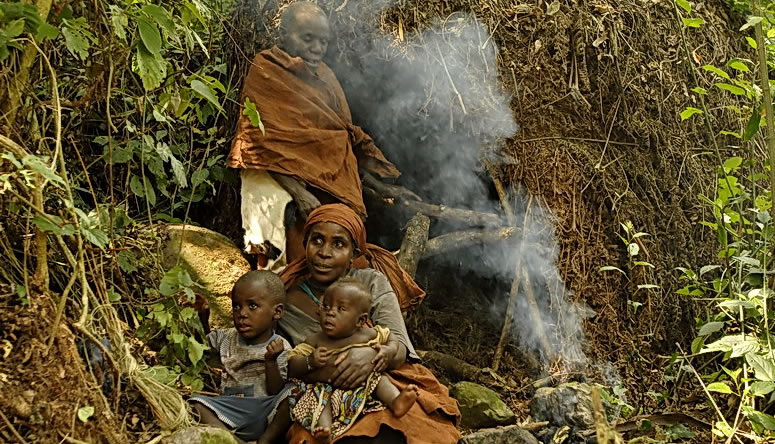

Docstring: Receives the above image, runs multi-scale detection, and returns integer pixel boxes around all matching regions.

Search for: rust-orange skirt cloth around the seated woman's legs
[287,363,460,444]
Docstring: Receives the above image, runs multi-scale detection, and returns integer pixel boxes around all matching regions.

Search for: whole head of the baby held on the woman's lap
[320,277,371,338]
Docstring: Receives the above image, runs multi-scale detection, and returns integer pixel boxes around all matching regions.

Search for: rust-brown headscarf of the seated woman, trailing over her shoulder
[280,204,425,311]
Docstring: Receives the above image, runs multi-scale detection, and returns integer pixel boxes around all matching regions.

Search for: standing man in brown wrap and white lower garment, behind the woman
[227,2,400,271]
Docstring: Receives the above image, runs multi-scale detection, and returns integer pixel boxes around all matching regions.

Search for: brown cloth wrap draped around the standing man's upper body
[227,46,400,216]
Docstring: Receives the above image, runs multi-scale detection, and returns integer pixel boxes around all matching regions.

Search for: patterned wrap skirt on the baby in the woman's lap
[288,373,385,439]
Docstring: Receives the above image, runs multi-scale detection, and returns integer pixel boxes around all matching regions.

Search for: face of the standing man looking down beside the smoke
[280,10,330,72]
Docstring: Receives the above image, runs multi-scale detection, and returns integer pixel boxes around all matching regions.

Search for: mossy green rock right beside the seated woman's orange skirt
[449,381,514,429]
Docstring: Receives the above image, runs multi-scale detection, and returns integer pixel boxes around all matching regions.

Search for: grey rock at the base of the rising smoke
[530,382,595,429]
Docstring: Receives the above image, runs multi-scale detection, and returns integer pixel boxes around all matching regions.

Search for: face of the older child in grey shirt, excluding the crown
[231,282,283,345]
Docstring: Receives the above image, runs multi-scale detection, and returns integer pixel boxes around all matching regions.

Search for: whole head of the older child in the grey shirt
[231,270,285,345]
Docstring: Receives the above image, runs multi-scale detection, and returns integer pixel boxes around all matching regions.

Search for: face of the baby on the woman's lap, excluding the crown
[320,286,368,338]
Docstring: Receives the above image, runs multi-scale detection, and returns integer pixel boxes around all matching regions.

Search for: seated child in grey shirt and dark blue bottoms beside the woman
[190,271,291,443]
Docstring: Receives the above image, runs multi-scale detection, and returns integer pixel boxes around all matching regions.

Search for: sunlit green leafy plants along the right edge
[676,0,775,441]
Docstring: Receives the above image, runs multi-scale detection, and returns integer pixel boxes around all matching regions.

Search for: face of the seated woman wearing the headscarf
[306,222,355,284]
